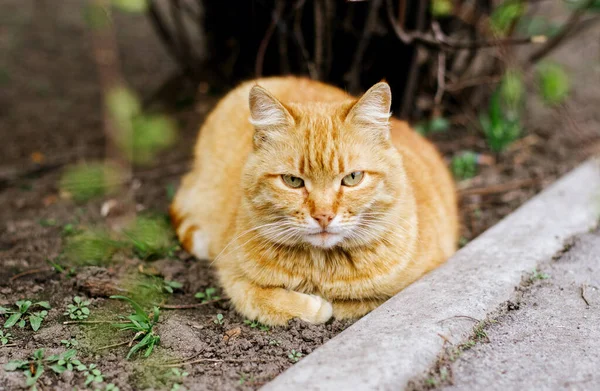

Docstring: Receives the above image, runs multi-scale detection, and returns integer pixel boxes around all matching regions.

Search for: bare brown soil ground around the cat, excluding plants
[0,0,600,390]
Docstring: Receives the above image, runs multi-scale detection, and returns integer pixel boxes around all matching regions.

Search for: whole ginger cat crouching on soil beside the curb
[171,77,458,325]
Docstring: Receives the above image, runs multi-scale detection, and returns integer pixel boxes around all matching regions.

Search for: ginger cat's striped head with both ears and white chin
[243,82,404,249]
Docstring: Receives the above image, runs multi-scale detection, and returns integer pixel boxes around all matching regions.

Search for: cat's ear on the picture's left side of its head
[249,85,294,147]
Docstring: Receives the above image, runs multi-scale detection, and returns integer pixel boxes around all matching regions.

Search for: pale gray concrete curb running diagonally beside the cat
[262,161,600,391]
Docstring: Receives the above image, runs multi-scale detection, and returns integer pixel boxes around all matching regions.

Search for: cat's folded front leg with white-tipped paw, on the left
[221,274,333,326]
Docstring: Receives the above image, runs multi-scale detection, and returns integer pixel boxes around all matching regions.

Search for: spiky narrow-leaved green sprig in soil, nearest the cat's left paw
[110,296,160,359]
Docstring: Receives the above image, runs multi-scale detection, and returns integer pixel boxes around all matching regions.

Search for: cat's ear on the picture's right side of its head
[346,82,392,138]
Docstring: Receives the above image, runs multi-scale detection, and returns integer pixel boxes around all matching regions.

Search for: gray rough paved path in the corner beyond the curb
[443,232,600,391]
